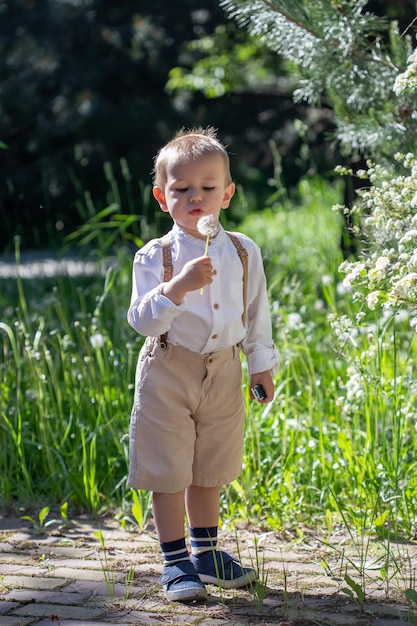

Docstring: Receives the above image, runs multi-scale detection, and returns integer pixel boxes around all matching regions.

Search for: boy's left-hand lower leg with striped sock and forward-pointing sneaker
[153,491,207,602]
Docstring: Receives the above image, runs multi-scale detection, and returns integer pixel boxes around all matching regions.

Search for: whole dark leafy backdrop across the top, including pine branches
[0,0,415,252]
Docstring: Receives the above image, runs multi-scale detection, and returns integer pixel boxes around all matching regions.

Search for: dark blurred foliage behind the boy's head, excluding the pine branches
[0,0,338,252]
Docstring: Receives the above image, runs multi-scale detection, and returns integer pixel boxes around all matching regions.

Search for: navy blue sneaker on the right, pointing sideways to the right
[191,550,256,589]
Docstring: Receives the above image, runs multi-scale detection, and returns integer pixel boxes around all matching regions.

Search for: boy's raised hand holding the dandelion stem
[162,256,213,305]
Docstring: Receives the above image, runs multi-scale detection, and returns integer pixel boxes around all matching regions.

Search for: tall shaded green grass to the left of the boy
[0,260,140,512]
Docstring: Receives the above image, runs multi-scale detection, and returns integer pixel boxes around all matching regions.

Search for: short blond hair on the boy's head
[153,126,232,189]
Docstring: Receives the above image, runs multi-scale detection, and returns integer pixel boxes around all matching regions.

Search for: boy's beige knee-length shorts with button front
[128,337,244,493]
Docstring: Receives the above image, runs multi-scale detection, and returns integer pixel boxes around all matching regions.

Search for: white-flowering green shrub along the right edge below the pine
[330,153,417,458]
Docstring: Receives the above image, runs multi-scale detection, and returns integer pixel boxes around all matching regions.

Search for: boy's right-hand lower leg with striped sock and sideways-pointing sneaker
[186,485,256,589]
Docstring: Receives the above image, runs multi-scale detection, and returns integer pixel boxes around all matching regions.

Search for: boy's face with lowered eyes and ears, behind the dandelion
[153,154,235,239]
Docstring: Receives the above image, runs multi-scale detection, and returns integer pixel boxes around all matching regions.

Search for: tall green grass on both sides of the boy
[0,176,417,538]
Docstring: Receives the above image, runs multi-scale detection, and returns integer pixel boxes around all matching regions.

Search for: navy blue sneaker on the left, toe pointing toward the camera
[158,561,207,602]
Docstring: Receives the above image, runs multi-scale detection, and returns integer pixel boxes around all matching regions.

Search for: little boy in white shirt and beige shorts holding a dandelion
[128,128,278,601]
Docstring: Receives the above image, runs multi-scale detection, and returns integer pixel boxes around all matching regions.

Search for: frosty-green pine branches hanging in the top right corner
[221,0,417,158]
